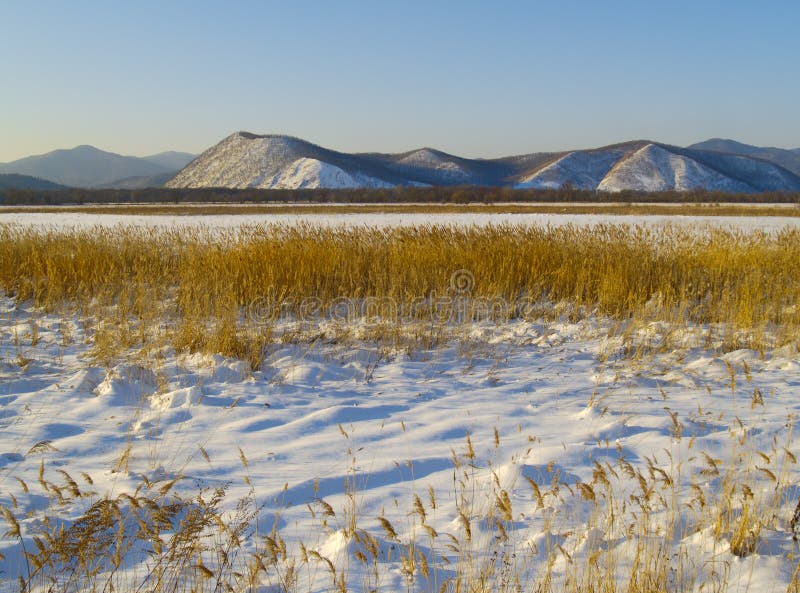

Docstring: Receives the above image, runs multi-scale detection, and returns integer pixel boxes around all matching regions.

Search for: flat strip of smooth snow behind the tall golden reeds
[0,209,800,231]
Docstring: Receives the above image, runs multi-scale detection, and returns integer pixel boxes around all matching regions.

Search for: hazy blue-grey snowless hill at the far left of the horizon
[0,146,180,187]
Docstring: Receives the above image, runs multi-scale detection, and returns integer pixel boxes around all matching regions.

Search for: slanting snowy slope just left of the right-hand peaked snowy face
[515,149,624,190]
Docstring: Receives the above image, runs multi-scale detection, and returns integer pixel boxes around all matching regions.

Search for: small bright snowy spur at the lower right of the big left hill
[264,158,392,189]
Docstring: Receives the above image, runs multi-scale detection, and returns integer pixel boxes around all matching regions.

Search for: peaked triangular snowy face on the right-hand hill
[597,144,753,192]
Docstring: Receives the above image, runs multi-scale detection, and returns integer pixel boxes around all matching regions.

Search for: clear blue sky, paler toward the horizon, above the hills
[0,0,800,161]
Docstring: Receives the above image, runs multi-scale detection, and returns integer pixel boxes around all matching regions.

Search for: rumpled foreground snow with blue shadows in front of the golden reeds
[0,297,800,592]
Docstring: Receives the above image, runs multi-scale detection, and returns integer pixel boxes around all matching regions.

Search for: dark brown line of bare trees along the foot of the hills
[0,186,800,206]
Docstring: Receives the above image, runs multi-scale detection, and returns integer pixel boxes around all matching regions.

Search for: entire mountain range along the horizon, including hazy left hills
[0,132,800,193]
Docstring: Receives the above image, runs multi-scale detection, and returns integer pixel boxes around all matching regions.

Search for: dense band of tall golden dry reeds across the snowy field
[0,224,800,355]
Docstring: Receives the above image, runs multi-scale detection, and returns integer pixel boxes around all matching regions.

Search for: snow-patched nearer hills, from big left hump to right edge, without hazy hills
[166,132,800,193]
